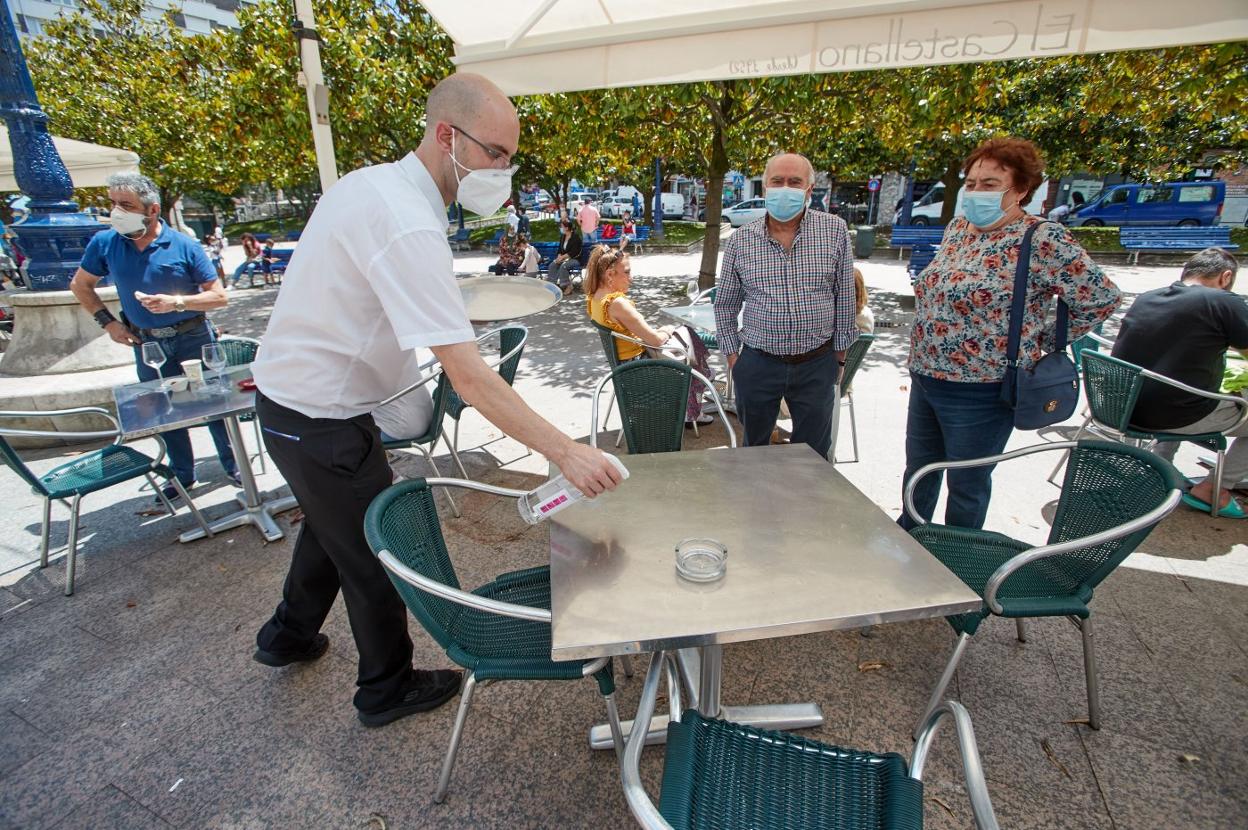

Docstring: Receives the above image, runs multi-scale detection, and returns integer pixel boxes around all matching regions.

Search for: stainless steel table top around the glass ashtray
[550,444,980,660]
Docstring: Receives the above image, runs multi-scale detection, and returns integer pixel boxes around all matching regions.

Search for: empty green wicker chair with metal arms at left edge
[0,407,212,597]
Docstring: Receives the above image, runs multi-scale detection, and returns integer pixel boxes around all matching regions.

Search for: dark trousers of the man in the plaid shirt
[733,344,837,458]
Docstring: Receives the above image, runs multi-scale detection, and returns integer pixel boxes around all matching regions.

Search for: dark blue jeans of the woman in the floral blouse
[899,372,1013,530]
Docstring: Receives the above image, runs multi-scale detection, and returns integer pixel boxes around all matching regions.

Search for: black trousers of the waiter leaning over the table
[256,392,412,713]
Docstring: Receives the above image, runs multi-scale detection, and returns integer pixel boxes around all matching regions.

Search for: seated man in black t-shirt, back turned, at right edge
[1113,248,1248,519]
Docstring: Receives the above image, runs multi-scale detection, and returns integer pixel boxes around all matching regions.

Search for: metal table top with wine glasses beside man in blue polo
[112,366,256,439]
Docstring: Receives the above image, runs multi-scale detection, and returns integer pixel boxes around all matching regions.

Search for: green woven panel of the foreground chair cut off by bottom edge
[659,710,924,830]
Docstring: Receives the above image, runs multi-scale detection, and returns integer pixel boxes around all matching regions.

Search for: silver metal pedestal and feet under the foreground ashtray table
[589,645,824,749]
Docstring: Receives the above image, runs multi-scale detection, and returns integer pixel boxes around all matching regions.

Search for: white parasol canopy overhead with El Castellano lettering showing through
[422,0,1248,95]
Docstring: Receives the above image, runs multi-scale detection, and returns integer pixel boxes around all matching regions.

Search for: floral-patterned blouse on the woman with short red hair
[910,215,1122,383]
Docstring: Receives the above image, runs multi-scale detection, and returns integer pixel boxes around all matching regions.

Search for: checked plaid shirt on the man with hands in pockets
[715,210,859,354]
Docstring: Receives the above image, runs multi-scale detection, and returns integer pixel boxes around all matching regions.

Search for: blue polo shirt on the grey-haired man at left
[81,222,217,328]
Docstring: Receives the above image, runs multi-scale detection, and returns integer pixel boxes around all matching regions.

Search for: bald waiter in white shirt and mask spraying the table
[252,74,619,726]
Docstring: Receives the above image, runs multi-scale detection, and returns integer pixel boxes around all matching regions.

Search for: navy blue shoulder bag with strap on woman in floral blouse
[1001,222,1080,429]
